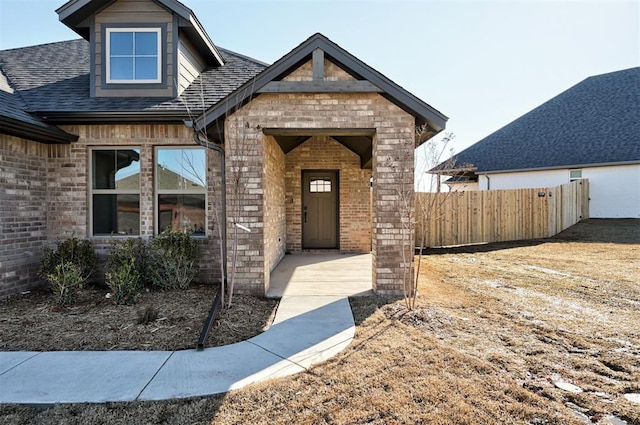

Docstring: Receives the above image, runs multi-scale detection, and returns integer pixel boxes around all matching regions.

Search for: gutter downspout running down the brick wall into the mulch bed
[184,121,227,351]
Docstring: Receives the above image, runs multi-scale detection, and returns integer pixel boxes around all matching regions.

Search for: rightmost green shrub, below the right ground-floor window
[150,232,198,289]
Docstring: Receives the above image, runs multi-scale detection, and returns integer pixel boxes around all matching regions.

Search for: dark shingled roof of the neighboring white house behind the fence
[432,67,640,174]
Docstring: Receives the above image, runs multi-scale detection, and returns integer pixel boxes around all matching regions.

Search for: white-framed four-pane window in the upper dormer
[105,28,162,84]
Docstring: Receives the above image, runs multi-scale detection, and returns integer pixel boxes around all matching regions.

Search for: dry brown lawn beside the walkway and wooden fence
[0,220,640,425]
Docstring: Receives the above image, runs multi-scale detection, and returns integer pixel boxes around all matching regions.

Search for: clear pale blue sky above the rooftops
[0,0,640,158]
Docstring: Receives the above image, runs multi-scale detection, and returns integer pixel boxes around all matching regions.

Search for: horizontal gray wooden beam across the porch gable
[257,80,383,93]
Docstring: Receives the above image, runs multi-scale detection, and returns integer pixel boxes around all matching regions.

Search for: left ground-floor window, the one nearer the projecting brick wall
[89,147,140,236]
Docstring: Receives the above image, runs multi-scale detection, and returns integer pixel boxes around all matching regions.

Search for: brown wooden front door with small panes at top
[302,170,338,249]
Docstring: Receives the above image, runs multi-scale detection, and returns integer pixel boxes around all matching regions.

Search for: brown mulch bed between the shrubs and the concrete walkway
[0,285,277,351]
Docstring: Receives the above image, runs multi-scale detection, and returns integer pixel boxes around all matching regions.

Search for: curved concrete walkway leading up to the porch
[0,256,371,404]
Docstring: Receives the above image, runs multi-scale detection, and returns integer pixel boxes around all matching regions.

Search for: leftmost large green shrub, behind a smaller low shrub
[39,237,97,284]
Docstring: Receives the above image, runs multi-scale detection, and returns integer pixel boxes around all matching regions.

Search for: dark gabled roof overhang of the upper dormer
[56,0,224,65]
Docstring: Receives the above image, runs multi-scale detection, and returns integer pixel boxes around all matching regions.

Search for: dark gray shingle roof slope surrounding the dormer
[0,39,266,113]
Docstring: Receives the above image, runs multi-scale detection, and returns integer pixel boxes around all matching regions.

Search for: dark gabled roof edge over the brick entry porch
[195,33,448,139]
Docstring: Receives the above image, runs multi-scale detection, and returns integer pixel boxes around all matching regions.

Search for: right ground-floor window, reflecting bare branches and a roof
[154,147,207,236]
